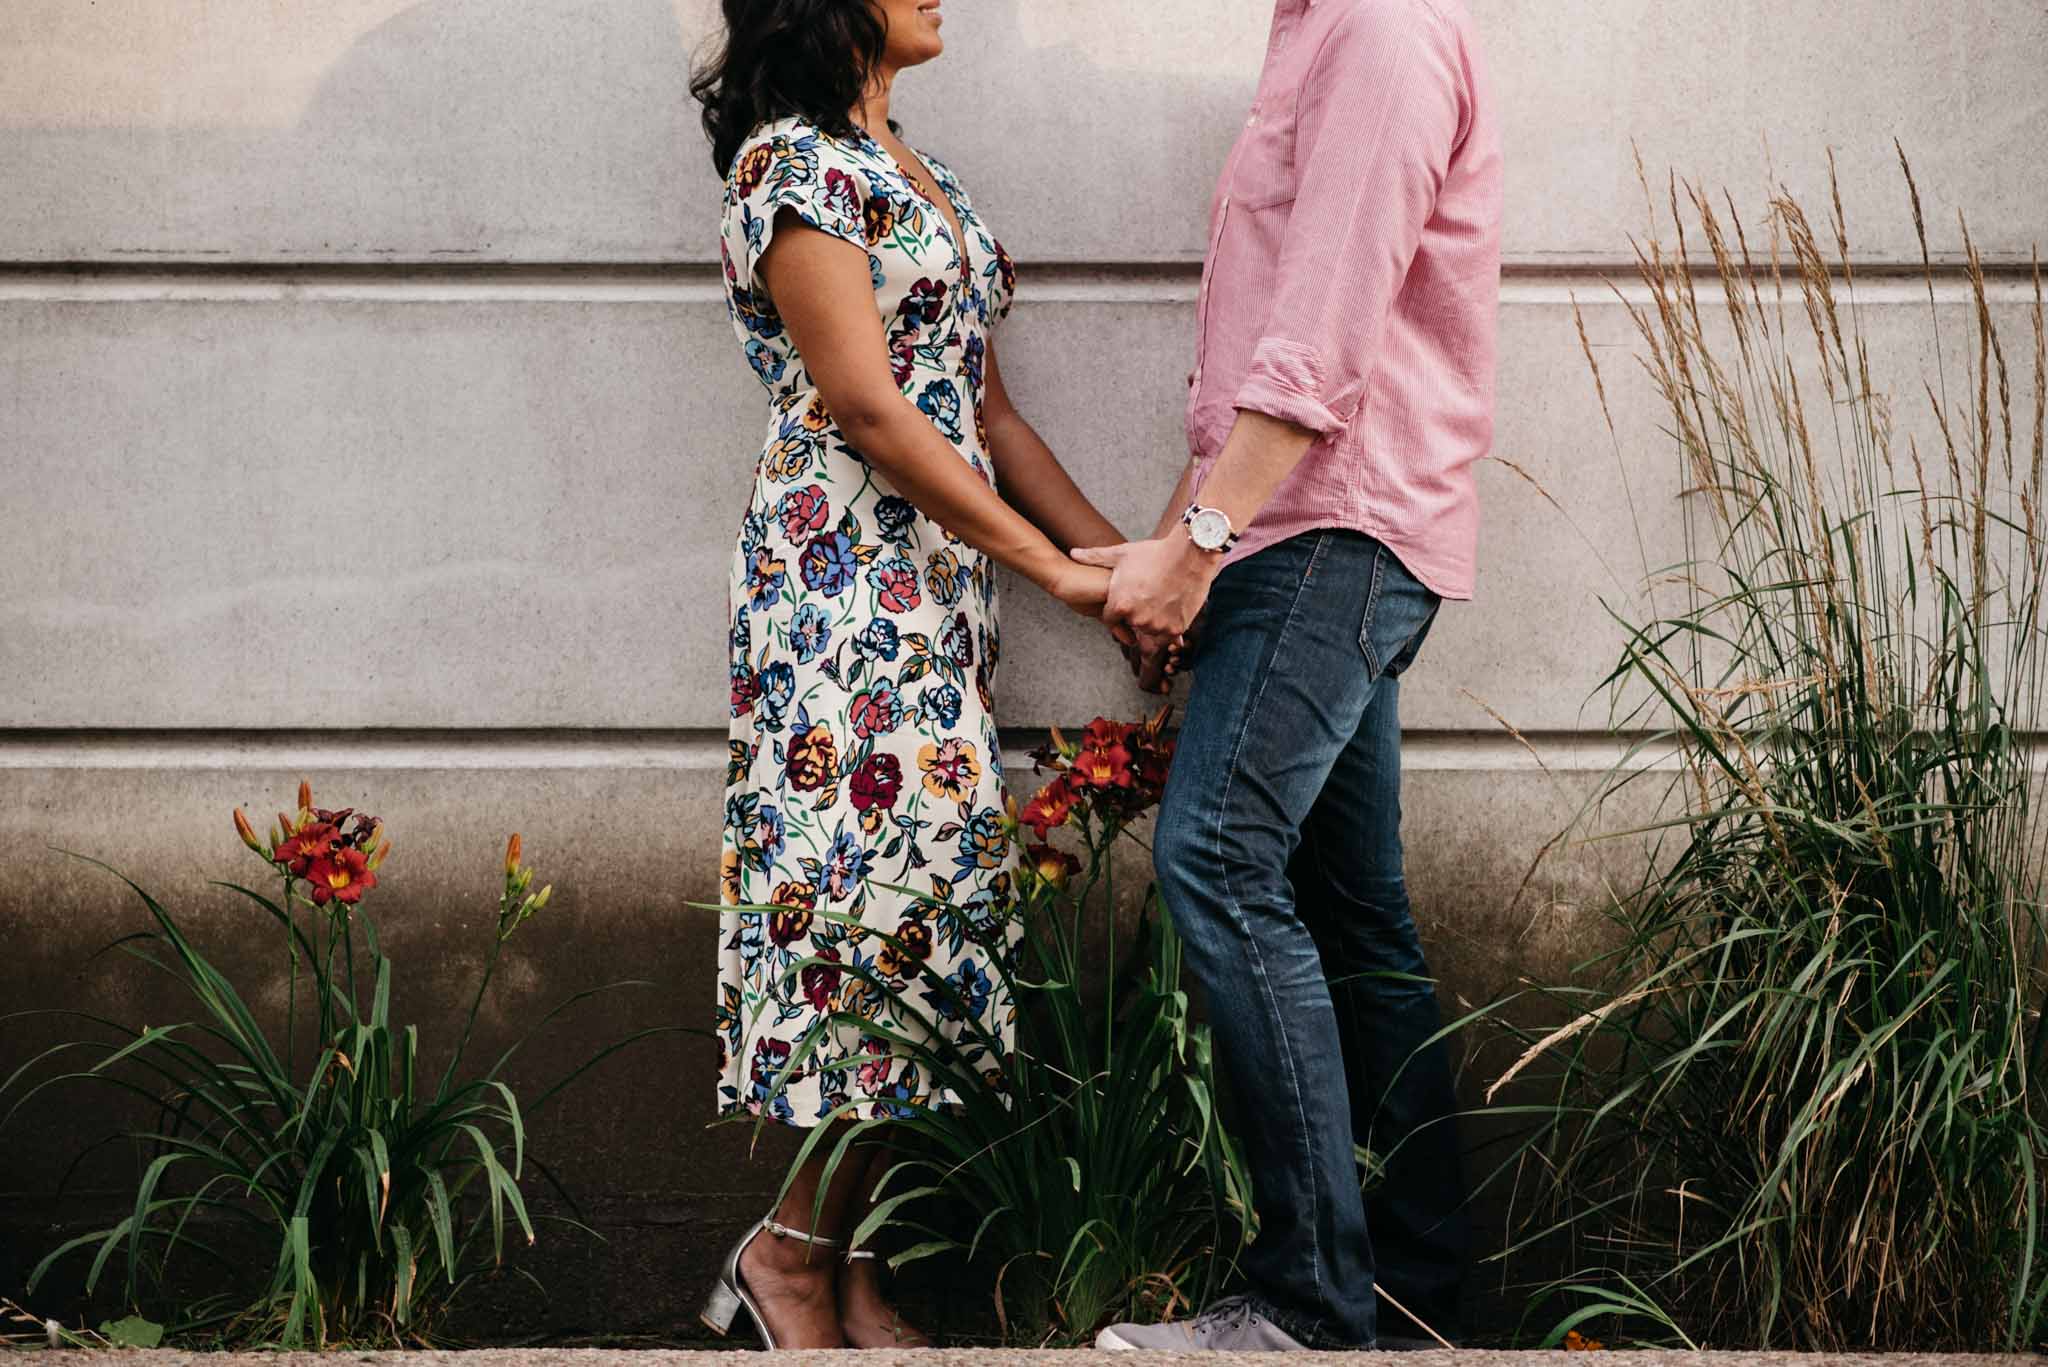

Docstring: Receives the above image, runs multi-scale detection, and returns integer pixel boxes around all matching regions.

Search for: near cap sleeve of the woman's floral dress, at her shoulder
[725,123,868,291]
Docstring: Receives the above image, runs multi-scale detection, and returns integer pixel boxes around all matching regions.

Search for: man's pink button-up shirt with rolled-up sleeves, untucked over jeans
[1188,0,1501,598]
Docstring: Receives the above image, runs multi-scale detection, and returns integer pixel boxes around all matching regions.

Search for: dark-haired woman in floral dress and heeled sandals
[692,0,1122,1349]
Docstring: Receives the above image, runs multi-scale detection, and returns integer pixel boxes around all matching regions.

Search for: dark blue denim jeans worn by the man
[1153,531,1470,1347]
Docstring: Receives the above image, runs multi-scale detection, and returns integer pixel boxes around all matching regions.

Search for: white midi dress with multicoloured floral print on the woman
[717,119,1016,1125]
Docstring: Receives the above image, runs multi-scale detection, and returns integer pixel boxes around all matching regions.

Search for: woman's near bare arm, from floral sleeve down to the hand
[758,209,1110,617]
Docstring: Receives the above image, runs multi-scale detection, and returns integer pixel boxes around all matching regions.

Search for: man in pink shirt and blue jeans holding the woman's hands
[1075,0,1501,1351]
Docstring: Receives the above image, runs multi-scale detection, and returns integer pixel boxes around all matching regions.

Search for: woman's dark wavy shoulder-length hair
[690,0,887,176]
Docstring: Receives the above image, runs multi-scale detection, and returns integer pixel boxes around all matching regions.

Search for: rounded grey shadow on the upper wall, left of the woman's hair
[274,0,702,260]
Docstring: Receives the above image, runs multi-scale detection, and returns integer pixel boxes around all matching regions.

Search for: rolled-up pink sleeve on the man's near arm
[1235,0,1466,437]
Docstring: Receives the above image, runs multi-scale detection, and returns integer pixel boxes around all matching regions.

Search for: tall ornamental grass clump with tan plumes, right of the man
[1495,152,2048,1351]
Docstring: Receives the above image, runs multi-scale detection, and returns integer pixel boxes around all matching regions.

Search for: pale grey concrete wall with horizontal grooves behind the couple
[0,0,2048,1328]
